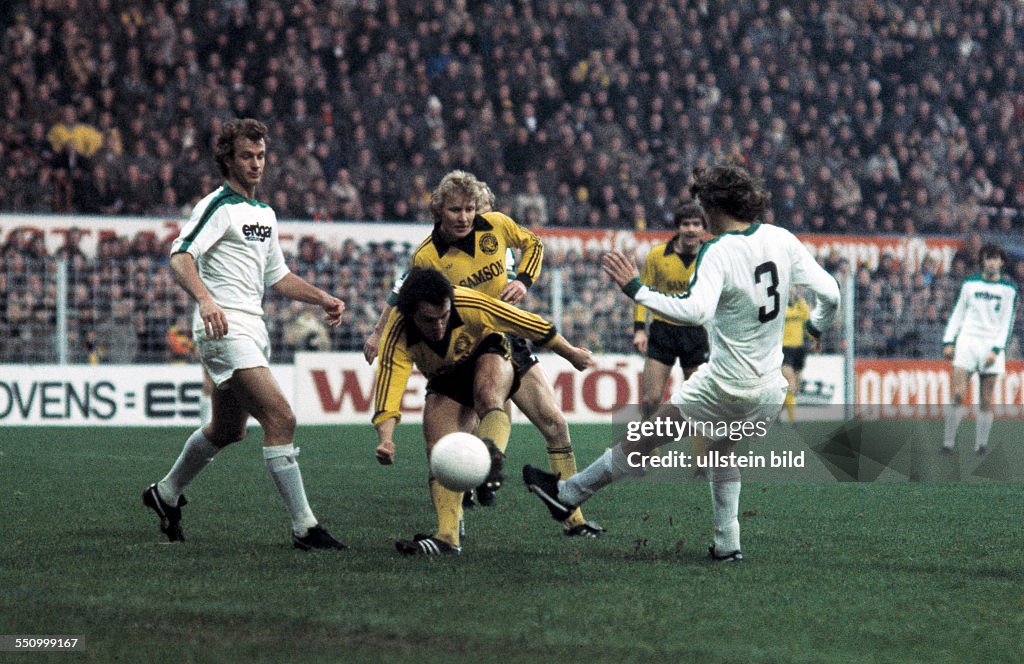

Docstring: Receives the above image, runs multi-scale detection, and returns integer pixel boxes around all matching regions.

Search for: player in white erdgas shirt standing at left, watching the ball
[142,119,346,550]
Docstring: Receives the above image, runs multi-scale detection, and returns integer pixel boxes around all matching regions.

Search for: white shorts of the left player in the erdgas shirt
[193,312,270,388]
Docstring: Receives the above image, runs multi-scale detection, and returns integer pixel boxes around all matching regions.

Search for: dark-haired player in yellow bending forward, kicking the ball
[373,267,593,555]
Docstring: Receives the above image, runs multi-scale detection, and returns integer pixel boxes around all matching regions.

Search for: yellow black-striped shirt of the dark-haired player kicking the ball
[373,286,557,425]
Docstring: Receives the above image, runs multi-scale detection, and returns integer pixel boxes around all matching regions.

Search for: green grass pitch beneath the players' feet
[0,423,1024,664]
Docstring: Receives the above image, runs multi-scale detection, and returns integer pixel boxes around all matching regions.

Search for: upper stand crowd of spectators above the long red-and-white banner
[0,0,1024,234]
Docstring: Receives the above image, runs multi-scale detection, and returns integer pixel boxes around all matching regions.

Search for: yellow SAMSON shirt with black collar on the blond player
[405,212,544,297]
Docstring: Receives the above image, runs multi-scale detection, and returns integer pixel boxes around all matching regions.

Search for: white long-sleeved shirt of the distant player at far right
[942,273,1017,352]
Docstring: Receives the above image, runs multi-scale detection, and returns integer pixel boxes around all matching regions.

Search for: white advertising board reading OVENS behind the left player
[0,365,294,427]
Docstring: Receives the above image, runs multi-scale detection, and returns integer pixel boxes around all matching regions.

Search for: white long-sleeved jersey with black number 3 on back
[633,223,840,386]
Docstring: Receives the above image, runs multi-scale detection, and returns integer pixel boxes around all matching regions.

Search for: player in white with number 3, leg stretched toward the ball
[523,166,840,561]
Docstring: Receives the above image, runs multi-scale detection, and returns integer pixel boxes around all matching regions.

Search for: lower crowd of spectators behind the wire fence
[0,226,1024,363]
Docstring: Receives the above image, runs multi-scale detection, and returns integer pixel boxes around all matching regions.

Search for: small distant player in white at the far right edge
[942,244,1017,454]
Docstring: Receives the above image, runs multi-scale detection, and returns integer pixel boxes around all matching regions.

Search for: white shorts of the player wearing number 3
[669,364,790,443]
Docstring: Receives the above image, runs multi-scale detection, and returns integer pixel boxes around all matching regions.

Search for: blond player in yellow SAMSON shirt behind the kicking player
[364,170,604,537]
